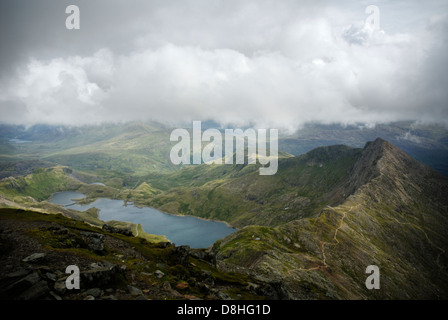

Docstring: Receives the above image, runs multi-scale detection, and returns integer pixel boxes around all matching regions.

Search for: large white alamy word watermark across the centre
[170,121,278,175]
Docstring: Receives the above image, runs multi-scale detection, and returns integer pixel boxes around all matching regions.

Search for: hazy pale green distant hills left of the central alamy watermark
[0,122,175,178]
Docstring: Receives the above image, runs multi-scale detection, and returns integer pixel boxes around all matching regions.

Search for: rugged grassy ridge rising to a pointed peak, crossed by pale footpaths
[212,139,448,299]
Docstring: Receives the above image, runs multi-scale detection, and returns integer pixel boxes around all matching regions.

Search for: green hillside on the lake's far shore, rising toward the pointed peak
[143,146,360,227]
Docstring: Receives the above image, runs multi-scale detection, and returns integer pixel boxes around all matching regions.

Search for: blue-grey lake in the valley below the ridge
[48,191,235,248]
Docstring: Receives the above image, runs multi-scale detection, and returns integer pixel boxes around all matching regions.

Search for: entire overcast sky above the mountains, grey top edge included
[0,0,448,132]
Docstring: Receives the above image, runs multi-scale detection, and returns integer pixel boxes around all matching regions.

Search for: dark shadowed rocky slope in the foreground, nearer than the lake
[0,209,276,300]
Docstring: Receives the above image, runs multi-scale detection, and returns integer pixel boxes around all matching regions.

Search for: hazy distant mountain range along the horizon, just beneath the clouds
[0,122,448,176]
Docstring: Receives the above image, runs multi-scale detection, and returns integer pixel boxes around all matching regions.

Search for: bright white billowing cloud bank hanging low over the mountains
[0,1,448,131]
